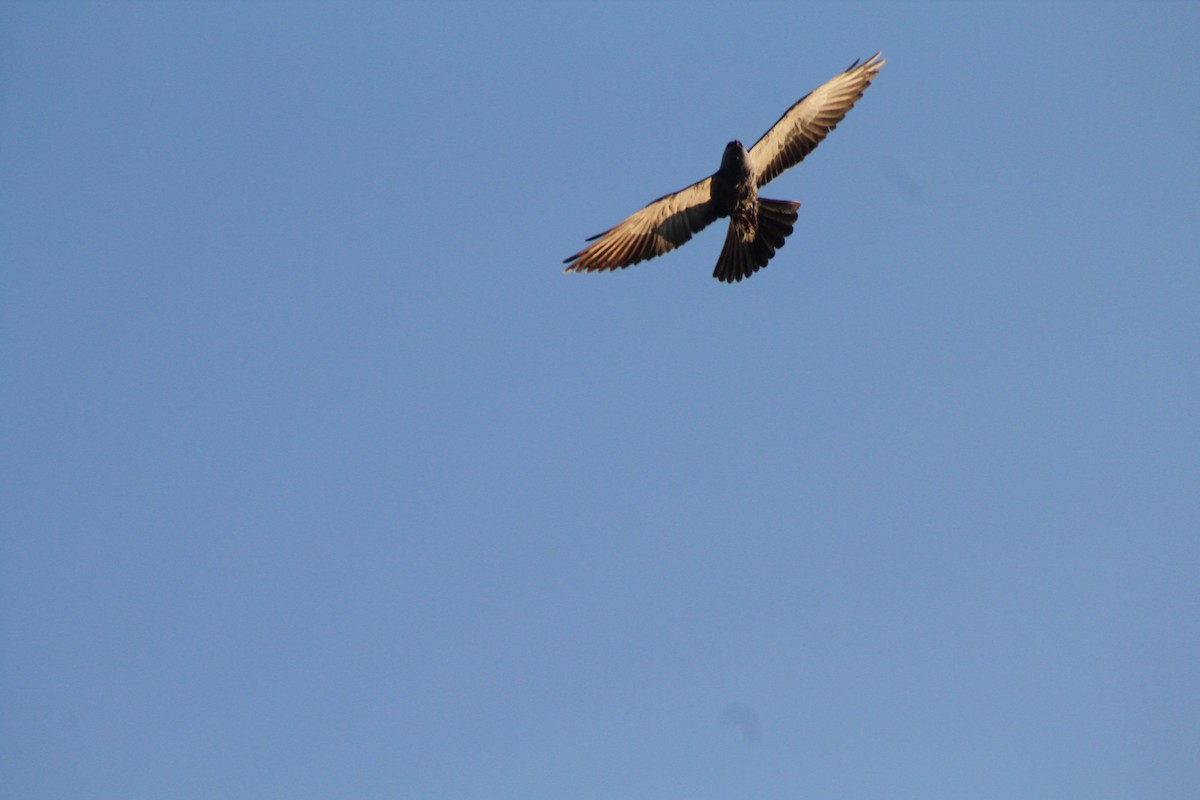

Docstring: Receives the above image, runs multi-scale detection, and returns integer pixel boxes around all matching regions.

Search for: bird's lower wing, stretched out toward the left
[563,178,719,272]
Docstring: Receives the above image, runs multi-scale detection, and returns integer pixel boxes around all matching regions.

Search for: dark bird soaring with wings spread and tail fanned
[563,53,884,283]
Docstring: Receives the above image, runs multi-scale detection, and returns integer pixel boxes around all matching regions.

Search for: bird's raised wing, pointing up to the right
[750,53,884,186]
